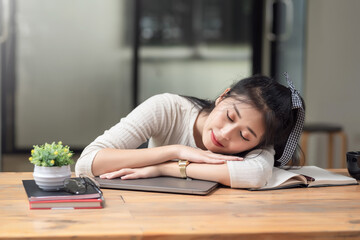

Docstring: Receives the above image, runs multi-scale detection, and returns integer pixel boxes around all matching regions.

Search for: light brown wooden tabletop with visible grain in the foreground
[0,170,360,240]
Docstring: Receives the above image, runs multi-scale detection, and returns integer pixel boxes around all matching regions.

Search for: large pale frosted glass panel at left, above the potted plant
[15,0,132,148]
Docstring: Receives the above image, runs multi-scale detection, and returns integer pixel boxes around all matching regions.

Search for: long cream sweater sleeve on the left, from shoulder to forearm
[75,94,169,176]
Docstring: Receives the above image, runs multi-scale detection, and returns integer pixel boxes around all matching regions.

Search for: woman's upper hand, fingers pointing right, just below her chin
[175,145,244,164]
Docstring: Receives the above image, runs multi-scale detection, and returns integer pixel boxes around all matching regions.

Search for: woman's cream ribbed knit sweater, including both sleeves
[75,93,275,188]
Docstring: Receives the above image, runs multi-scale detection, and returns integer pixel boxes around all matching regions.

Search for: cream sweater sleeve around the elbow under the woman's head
[227,149,275,188]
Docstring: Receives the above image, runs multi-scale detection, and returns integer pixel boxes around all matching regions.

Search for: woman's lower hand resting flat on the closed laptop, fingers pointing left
[100,165,160,180]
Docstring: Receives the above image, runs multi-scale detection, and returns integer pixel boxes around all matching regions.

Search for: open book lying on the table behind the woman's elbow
[255,166,358,190]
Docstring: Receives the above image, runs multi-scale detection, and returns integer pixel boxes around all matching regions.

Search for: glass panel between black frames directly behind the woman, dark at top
[139,0,254,101]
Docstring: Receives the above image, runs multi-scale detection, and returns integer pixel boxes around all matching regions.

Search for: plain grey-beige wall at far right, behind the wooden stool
[305,0,360,165]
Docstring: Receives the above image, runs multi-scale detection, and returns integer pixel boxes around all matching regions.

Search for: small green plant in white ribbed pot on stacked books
[29,141,74,191]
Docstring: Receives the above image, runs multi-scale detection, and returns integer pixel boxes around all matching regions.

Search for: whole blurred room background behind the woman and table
[0,0,360,171]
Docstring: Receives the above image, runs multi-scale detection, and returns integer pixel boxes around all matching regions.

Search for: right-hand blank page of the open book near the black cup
[288,166,357,187]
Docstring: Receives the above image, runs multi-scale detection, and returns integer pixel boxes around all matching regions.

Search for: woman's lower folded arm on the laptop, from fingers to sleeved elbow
[100,147,274,188]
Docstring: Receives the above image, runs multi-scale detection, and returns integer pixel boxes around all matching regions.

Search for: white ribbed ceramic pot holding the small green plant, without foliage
[33,165,71,191]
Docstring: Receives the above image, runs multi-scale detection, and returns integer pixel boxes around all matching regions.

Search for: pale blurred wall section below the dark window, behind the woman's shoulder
[140,57,251,101]
